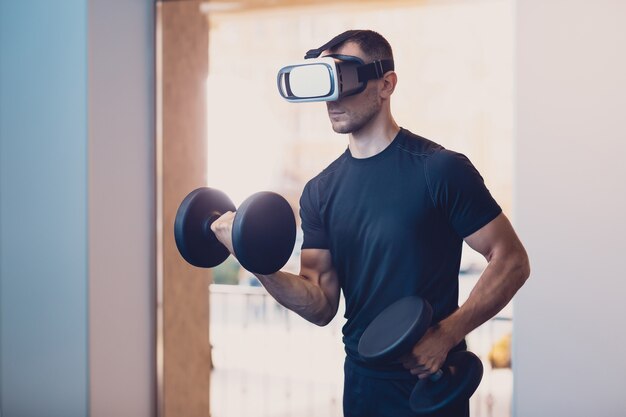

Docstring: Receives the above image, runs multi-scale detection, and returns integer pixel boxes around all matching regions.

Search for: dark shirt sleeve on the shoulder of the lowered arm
[425,149,502,238]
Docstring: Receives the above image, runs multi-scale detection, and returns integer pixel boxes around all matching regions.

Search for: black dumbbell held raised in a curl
[174,187,296,275]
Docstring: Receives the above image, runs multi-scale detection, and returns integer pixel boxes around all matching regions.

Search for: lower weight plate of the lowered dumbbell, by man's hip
[409,351,483,414]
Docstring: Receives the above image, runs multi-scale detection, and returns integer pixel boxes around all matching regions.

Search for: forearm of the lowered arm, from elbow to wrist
[439,255,530,343]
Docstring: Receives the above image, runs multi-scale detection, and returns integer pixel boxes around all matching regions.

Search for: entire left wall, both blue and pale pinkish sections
[0,0,156,417]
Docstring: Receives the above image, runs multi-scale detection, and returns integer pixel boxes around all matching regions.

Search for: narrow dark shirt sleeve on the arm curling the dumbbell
[300,180,329,249]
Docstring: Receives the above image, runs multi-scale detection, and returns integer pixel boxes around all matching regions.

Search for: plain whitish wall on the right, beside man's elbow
[513,0,626,417]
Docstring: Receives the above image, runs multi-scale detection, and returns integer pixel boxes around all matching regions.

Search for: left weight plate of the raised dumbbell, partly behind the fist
[174,187,235,268]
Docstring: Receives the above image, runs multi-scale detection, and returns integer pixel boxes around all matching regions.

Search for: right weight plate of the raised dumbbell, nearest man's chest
[233,191,296,274]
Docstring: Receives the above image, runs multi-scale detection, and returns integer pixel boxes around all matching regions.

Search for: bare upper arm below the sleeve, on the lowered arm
[465,213,523,260]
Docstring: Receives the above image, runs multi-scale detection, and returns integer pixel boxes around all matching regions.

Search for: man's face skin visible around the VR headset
[325,41,382,133]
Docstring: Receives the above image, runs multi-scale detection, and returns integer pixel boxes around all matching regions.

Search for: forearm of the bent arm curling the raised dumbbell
[255,271,335,326]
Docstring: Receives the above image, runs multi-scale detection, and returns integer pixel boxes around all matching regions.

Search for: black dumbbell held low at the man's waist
[358,296,483,414]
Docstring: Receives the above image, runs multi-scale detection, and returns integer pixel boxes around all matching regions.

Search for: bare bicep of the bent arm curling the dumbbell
[300,249,340,312]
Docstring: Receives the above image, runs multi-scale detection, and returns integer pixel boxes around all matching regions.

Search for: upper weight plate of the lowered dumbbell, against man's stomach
[358,296,433,363]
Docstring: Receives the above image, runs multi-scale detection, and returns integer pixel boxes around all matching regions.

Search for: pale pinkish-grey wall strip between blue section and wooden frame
[88,0,156,417]
